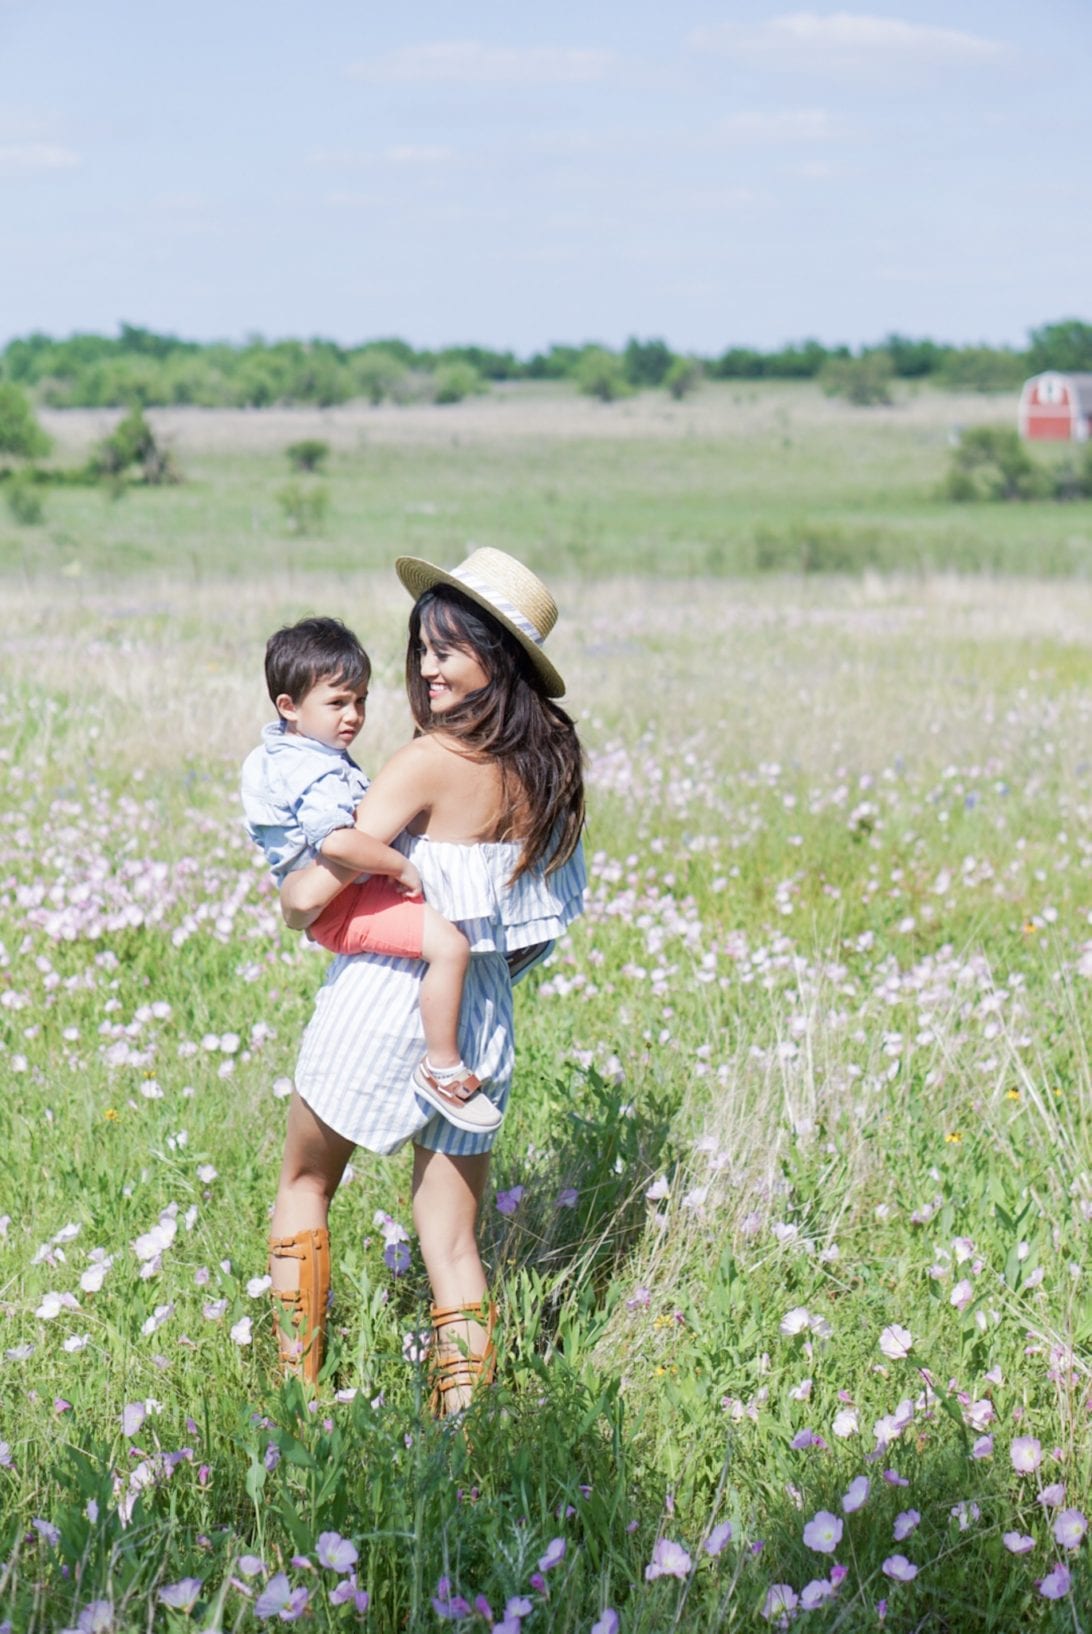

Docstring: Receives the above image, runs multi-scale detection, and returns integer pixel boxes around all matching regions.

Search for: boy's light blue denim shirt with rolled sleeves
[240,721,368,879]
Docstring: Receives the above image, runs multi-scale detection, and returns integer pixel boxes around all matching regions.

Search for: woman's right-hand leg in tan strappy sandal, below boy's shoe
[414,1145,489,1412]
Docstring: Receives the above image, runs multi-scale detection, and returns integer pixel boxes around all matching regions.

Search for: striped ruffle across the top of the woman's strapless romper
[394,835,585,954]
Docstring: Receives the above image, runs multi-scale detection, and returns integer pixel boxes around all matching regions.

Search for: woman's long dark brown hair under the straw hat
[405,585,584,881]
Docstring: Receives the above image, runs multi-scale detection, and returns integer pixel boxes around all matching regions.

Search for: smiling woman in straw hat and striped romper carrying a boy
[270,549,584,1413]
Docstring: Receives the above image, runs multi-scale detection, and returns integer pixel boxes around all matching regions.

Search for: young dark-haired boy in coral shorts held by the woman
[242,618,502,1134]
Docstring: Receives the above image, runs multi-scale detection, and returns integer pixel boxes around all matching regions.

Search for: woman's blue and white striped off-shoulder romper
[287,835,585,1157]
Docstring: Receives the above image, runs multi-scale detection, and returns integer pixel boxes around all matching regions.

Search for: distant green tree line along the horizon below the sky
[0,319,1092,409]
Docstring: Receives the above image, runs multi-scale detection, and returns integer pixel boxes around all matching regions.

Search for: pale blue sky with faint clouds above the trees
[0,0,1092,353]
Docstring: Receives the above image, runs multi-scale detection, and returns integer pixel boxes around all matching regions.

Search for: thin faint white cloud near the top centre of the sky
[348,39,615,87]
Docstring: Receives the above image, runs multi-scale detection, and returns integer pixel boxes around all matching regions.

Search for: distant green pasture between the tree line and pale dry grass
[0,384,1092,580]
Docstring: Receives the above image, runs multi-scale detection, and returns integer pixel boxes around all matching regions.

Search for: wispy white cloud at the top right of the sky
[687,11,1009,69]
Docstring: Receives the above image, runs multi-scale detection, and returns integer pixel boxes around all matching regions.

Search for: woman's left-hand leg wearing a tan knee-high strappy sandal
[270,1095,353,1382]
